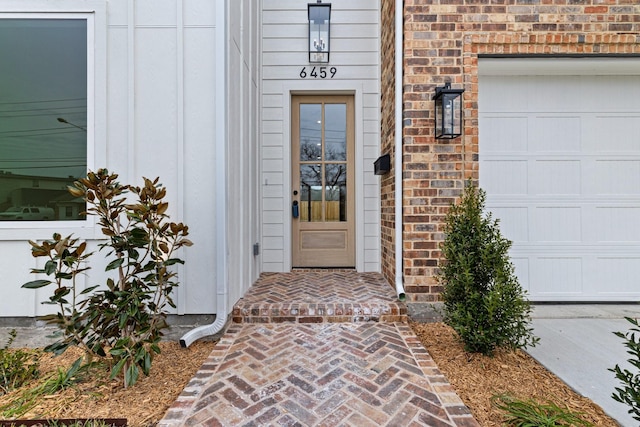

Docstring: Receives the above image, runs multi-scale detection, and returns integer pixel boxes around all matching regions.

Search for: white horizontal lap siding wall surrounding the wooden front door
[260,0,380,272]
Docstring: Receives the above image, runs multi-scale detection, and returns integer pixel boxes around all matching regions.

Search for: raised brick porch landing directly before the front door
[232,270,407,323]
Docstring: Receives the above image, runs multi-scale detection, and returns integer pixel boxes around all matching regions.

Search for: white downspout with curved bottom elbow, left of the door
[180,0,229,347]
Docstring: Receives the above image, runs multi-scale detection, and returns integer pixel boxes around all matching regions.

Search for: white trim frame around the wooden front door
[282,81,365,271]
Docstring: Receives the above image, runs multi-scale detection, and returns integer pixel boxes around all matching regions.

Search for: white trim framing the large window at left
[0,0,107,241]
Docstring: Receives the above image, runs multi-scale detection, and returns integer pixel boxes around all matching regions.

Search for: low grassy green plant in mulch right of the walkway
[492,394,593,427]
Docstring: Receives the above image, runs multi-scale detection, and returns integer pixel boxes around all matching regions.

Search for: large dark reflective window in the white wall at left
[0,14,91,221]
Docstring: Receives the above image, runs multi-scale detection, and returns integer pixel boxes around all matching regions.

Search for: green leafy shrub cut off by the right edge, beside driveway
[609,317,640,421]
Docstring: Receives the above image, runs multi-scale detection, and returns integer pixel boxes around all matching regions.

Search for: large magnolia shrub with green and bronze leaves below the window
[22,169,191,387]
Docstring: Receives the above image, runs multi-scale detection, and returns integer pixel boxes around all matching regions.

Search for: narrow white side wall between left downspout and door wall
[227,0,259,304]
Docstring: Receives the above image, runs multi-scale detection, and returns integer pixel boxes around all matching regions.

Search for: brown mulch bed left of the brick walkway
[0,341,215,427]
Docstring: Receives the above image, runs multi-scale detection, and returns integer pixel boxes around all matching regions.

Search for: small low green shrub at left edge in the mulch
[0,329,38,396]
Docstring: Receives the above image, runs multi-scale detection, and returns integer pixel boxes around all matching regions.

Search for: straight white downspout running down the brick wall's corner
[394,0,406,301]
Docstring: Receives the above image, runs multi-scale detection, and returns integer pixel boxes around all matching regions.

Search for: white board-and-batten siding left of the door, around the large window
[0,0,259,317]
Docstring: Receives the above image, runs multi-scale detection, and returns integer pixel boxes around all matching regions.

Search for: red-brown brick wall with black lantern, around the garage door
[398,0,640,301]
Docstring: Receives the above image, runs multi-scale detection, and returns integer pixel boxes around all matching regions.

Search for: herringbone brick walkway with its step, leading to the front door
[158,272,478,427]
